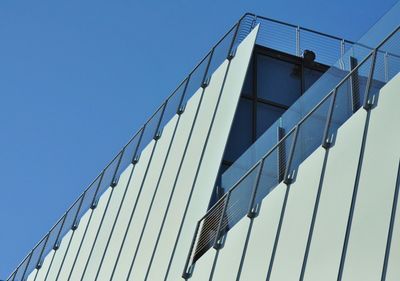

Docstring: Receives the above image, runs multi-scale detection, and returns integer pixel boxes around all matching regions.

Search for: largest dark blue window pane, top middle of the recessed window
[257,55,301,106]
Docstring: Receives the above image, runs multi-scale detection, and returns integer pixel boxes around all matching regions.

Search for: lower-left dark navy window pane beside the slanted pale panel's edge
[224,98,253,162]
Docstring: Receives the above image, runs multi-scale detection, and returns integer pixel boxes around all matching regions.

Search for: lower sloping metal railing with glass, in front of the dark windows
[182,23,400,279]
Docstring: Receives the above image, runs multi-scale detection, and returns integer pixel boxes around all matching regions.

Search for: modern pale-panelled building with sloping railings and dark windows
[7,4,400,281]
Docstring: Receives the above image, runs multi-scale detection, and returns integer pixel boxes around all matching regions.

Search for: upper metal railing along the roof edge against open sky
[7,13,353,281]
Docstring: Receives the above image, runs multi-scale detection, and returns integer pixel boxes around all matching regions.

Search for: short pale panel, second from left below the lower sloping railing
[209,217,250,281]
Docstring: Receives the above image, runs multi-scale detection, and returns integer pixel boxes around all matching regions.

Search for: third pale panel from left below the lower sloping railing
[240,183,286,281]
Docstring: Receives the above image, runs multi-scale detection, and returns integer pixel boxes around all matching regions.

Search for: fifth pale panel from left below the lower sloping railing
[304,110,366,281]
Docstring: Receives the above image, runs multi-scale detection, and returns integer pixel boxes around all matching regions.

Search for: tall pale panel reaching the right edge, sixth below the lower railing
[342,76,400,281]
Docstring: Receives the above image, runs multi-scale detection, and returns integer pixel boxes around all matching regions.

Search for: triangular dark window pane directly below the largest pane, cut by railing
[256,102,285,138]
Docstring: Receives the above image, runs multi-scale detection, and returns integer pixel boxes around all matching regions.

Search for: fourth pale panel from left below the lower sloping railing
[271,147,325,280]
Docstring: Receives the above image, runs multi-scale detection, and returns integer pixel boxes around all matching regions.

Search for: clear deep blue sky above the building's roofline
[0,0,397,279]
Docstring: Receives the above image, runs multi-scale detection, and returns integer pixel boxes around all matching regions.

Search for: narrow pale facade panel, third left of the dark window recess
[122,90,201,280]
